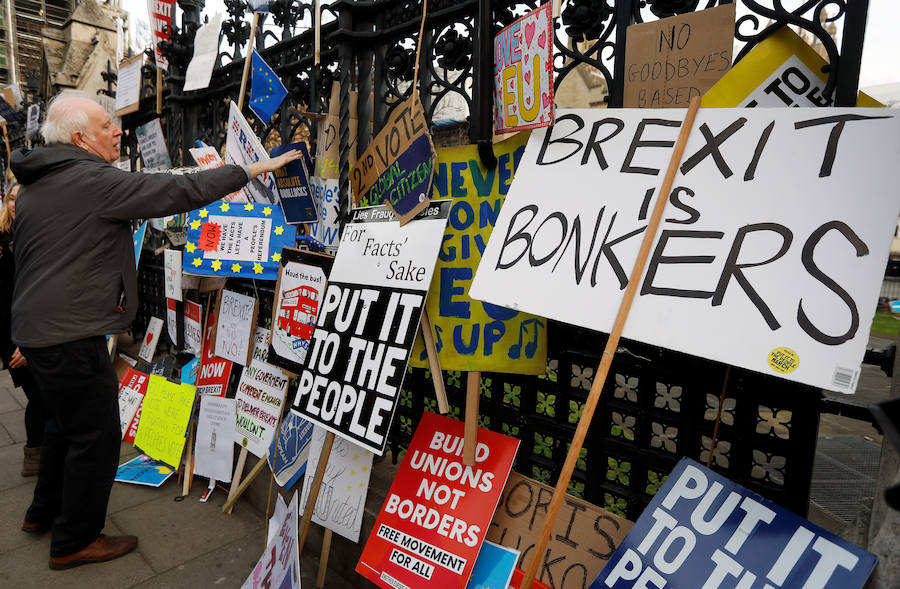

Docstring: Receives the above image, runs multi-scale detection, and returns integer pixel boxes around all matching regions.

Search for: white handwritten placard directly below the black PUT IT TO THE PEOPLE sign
[300,427,373,542]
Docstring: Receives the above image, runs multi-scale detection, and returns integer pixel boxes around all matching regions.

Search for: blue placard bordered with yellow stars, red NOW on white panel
[181,200,297,280]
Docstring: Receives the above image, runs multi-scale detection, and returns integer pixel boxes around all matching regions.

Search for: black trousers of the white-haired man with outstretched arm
[22,336,122,556]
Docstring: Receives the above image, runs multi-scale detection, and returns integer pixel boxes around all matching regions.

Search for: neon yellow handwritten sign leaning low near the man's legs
[134,375,197,469]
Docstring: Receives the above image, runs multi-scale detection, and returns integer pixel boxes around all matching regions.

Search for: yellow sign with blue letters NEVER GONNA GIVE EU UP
[412,132,547,374]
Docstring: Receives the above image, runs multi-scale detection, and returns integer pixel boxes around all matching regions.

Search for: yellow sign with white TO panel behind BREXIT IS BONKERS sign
[700,27,884,108]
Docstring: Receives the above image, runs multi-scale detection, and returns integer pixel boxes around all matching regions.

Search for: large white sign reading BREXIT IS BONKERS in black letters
[470,108,900,393]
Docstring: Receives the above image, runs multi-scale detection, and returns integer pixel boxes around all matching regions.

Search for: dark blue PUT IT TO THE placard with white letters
[590,458,876,589]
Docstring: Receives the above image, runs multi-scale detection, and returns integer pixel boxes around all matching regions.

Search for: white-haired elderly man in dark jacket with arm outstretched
[11,93,299,569]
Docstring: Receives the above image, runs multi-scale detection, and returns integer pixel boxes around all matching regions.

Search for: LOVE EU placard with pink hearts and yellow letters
[494,2,554,133]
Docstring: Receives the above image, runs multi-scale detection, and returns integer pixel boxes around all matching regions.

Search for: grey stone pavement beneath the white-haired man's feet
[0,370,352,589]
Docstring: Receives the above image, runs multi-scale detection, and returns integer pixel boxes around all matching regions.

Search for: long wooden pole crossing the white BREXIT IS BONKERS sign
[520,97,700,589]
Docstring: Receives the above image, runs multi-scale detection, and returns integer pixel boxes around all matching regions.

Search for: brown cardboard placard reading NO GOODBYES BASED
[624,4,735,108]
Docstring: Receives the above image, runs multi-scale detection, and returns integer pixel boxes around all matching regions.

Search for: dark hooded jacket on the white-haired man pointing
[11,144,248,348]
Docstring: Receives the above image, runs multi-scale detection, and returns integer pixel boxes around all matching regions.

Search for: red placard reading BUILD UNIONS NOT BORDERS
[356,413,519,589]
